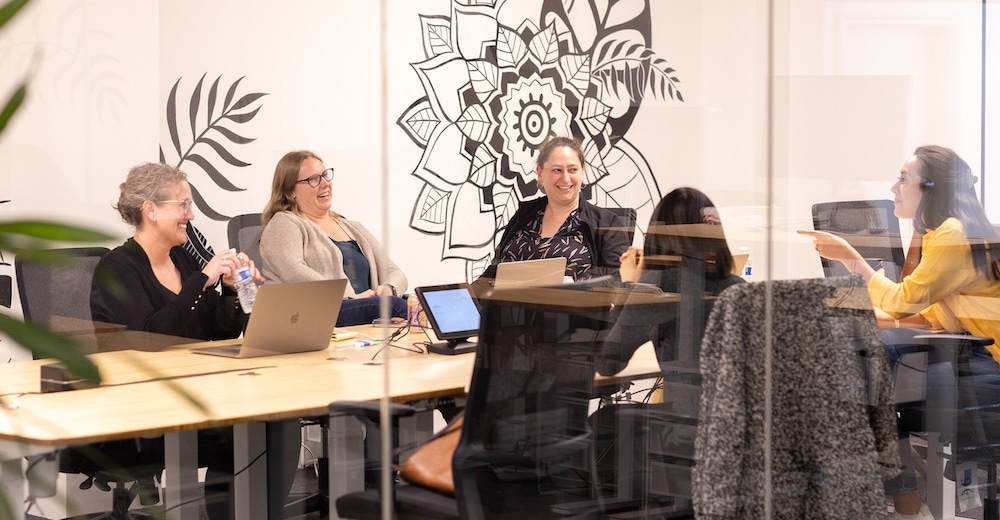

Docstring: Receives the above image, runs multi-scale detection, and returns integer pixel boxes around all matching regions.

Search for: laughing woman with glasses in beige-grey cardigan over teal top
[260,151,406,327]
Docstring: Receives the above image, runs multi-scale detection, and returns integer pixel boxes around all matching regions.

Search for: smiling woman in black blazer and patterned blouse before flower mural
[475,137,629,293]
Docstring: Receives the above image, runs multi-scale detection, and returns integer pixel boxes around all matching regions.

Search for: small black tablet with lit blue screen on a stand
[415,283,480,341]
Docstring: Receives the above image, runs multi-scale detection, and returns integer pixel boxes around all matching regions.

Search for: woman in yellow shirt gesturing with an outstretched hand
[799,146,1000,520]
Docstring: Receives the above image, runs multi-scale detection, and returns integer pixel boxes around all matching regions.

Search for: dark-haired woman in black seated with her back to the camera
[596,188,743,375]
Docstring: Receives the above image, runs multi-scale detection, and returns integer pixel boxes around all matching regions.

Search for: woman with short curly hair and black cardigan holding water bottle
[90,163,278,520]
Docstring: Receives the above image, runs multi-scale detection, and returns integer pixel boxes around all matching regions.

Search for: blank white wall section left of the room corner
[0,0,159,239]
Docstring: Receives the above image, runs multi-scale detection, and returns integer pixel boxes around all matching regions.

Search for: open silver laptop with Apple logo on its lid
[191,278,348,358]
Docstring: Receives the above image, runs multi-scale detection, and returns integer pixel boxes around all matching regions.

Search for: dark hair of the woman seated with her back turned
[643,188,733,278]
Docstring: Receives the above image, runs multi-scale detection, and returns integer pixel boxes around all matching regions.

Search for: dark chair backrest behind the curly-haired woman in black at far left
[14,247,108,332]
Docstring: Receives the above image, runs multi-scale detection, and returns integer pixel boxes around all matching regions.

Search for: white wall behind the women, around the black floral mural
[0,0,988,358]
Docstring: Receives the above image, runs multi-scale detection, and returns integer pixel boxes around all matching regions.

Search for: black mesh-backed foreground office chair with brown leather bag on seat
[337,287,611,520]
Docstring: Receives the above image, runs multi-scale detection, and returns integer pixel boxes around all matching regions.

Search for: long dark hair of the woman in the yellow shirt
[913,146,1000,280]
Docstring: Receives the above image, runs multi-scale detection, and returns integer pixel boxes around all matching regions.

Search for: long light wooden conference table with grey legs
[0,292,660,519]
